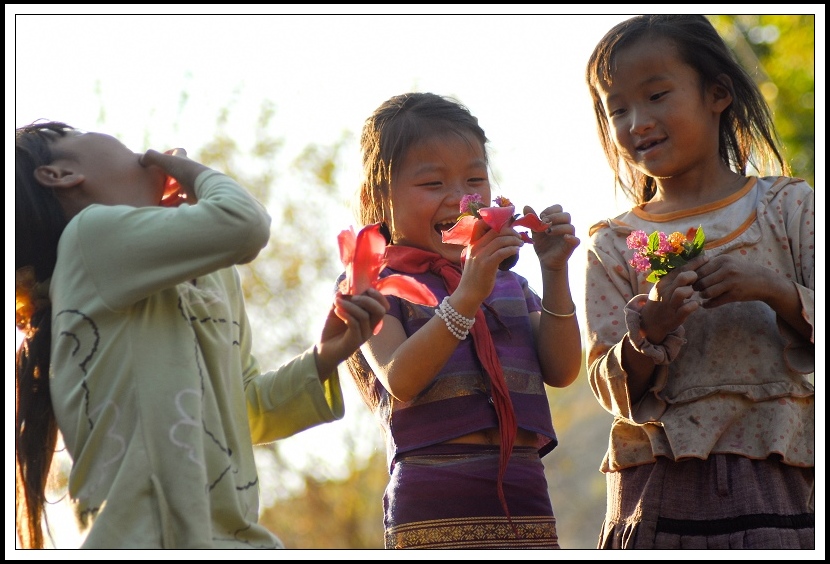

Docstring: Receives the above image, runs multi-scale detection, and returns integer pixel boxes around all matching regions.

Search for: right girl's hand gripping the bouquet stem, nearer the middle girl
[640,255,709,344]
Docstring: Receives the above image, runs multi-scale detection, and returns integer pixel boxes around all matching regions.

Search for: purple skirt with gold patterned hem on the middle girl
[383,444,559,549]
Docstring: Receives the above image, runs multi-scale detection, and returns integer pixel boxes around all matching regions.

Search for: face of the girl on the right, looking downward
[599,38,732,179]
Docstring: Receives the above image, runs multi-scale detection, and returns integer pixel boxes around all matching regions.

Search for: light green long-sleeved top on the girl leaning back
[50,171,344,549]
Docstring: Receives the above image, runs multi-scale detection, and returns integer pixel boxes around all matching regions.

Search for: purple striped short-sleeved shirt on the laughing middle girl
[354,268,557,465]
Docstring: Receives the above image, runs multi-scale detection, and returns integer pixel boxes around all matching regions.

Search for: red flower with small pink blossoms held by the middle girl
[441,194,548,270]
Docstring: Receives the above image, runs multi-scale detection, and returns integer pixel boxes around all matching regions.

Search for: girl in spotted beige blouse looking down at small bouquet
[586,15,816,549]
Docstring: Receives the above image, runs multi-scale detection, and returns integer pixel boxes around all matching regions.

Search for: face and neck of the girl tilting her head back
[52,132,166,207]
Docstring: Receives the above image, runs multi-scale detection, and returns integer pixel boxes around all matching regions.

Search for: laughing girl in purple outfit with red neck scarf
[341,93,582,548]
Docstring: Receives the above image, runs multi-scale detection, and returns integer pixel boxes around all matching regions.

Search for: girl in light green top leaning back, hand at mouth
[15,122,389,549]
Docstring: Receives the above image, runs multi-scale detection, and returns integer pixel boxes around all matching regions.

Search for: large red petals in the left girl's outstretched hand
[337,223,438,307]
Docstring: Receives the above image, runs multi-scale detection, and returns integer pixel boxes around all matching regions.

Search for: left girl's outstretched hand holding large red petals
[317,288,389,379]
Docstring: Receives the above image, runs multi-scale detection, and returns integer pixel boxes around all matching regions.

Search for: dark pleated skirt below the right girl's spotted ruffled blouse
[598,454,816,549]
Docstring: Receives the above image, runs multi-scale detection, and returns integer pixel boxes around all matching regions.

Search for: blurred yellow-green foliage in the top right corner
[708,14,816,187]
